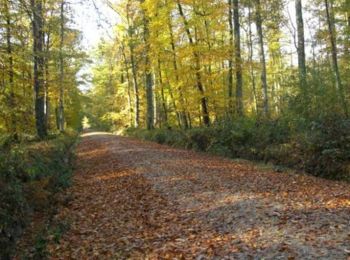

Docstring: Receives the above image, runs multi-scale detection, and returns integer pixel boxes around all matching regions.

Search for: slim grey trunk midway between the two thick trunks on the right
[255,0,269,116]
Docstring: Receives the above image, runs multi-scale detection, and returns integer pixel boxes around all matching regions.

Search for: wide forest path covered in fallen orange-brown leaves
[48,133,350,259]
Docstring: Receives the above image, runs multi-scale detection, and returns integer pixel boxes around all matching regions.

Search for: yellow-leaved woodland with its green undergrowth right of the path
[85,0,350,177]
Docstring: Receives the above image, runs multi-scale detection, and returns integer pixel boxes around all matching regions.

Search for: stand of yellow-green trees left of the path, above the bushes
[0,0,86,139]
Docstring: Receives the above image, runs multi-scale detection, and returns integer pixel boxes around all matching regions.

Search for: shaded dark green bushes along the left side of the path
[0,132,76,259]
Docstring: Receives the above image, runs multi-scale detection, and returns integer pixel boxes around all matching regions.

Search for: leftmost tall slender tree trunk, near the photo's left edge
[4,1,17,136]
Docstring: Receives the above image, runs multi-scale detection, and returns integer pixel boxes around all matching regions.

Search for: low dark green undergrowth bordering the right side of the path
[125,116,350,180]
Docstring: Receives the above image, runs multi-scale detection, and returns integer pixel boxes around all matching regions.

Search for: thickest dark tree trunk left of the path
[30,0,47,139]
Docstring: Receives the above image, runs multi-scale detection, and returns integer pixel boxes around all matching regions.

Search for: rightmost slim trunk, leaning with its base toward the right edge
[324,0,349,117]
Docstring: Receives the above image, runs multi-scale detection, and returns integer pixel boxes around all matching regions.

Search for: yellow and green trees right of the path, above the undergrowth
[89,0,350,129]
